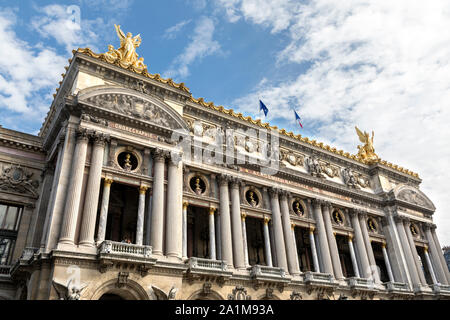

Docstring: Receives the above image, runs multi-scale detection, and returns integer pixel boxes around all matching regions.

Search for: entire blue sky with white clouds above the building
[0,0,450,244]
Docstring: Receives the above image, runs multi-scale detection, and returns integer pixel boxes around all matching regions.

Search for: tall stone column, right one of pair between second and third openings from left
[231,179,245,269]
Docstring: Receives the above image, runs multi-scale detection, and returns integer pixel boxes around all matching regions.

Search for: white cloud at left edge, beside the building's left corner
[0,10,67,117]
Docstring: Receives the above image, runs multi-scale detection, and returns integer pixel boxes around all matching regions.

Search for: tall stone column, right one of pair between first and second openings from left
[166,154,183,259]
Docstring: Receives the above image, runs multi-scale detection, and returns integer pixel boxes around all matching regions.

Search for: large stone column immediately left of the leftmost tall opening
[80,134,106,247]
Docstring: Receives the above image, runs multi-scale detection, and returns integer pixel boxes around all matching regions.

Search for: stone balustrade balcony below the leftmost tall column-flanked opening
[98,240,157,271]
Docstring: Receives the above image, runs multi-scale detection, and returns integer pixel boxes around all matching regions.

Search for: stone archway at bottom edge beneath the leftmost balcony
[90,279,151,300]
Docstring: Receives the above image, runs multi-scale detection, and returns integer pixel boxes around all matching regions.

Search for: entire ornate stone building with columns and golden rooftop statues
[0,29,450,300]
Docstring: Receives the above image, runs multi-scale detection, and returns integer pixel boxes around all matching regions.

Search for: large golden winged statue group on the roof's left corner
[103,25,147,73]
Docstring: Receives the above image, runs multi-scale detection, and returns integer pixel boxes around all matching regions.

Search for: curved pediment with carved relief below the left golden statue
[77,86,189,130]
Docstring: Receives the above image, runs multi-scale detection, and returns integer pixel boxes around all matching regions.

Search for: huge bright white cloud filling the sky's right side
[216,0,450,245]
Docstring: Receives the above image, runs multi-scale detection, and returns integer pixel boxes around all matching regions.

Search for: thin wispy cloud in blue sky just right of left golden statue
[165,17,220,77]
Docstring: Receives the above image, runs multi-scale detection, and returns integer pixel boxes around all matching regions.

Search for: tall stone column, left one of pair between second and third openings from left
[219,175,233,268]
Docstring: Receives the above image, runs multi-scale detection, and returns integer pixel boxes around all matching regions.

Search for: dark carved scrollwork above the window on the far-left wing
[0,165,39,197]
